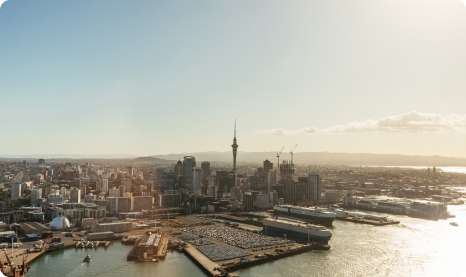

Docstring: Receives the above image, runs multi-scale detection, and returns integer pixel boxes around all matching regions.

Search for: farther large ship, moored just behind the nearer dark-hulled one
[273,205,336,227]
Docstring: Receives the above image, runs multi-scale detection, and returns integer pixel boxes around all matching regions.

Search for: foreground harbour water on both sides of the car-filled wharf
[28,205,466,277]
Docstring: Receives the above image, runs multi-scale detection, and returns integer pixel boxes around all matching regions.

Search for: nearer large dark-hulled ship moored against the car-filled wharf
[262,218,332,245]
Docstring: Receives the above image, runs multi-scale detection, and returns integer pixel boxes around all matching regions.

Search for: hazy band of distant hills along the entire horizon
[0,151,466,166]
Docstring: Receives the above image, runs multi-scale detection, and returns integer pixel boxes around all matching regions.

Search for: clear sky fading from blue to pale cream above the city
[0,0,466,157]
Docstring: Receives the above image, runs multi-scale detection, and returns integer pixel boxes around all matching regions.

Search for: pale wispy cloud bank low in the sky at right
[259,111,466,136]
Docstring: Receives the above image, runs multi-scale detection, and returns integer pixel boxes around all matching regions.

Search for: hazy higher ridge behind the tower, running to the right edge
[153,152,466,166]
